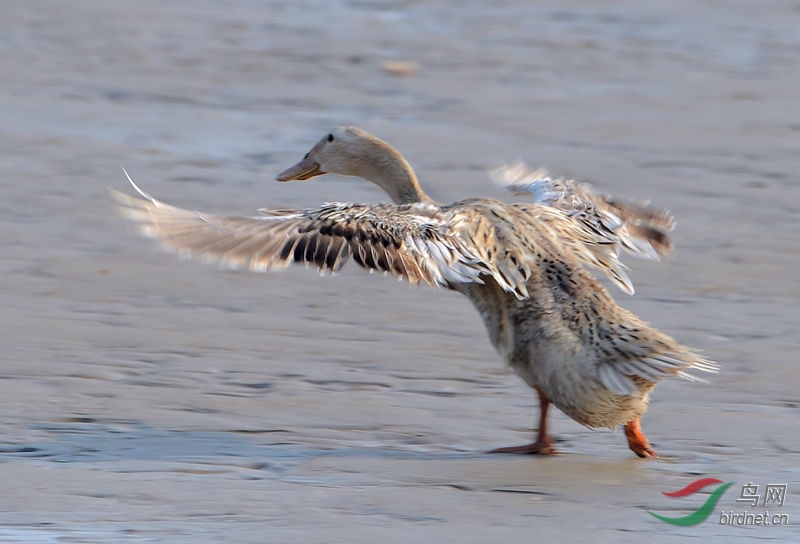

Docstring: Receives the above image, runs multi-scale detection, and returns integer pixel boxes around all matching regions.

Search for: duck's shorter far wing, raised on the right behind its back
[490,162,675,294]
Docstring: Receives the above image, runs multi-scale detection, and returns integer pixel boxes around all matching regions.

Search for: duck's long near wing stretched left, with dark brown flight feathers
[111,173,527,298]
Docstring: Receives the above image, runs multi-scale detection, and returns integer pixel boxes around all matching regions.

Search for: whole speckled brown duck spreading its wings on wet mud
[112,126,719,458]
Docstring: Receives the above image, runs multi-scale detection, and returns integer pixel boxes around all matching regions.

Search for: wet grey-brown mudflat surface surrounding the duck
[0,1,800,543]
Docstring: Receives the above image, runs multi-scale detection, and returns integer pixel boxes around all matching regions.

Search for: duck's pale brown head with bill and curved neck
[277,127,429,203]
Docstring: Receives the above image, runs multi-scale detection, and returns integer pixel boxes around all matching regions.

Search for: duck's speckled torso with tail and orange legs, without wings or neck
[455,197,714,457]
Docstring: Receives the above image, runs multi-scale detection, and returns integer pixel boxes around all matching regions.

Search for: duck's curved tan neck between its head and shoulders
[361,142,433,204]
